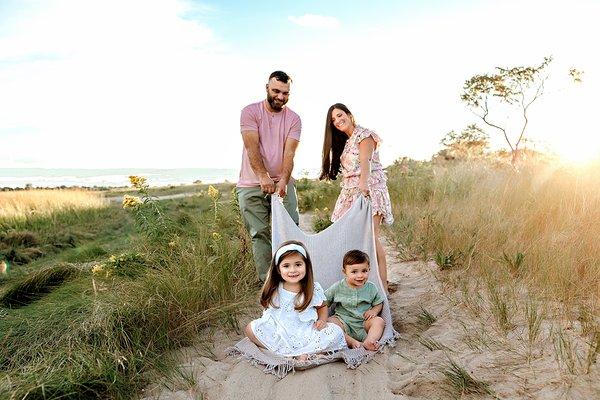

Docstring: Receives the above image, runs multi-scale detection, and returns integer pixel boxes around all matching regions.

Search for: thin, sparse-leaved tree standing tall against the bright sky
[460,57,552,164]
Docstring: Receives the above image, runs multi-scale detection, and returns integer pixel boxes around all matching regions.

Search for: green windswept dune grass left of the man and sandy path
[0,182,258,399]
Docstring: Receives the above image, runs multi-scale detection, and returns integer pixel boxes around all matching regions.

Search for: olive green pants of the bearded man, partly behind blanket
[236,182,299,282]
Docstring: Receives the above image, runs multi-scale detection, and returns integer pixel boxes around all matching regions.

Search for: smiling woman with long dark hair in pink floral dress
[319,103,394,292]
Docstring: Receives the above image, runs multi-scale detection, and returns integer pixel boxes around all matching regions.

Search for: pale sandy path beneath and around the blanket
[142,215,600,400]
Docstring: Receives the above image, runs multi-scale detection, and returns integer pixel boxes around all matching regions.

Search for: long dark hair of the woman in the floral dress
[319,103,354,180]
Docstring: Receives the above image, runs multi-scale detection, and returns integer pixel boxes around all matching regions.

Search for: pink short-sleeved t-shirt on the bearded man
[237,100,302,187]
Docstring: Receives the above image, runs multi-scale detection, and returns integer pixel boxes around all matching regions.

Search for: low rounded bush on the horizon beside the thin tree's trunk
[438,124,489,160]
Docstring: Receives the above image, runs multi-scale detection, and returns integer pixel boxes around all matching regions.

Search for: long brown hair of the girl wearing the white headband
[260,240,315,311]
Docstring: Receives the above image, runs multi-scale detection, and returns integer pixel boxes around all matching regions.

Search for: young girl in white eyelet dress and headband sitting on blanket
[245,241,346,360]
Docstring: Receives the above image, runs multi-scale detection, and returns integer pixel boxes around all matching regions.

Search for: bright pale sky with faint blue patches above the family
[0,0,600,174]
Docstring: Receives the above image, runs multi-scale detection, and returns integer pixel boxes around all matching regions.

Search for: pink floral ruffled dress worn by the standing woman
[331,125,394,225]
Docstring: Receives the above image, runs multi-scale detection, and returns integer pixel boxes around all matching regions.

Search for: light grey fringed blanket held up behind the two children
[229,196,399,378]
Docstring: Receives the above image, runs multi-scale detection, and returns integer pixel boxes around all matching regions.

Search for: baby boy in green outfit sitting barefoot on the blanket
[325,250,385,351]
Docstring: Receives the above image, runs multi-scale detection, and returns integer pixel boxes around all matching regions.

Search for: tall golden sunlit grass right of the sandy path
[388,161,600,312]
